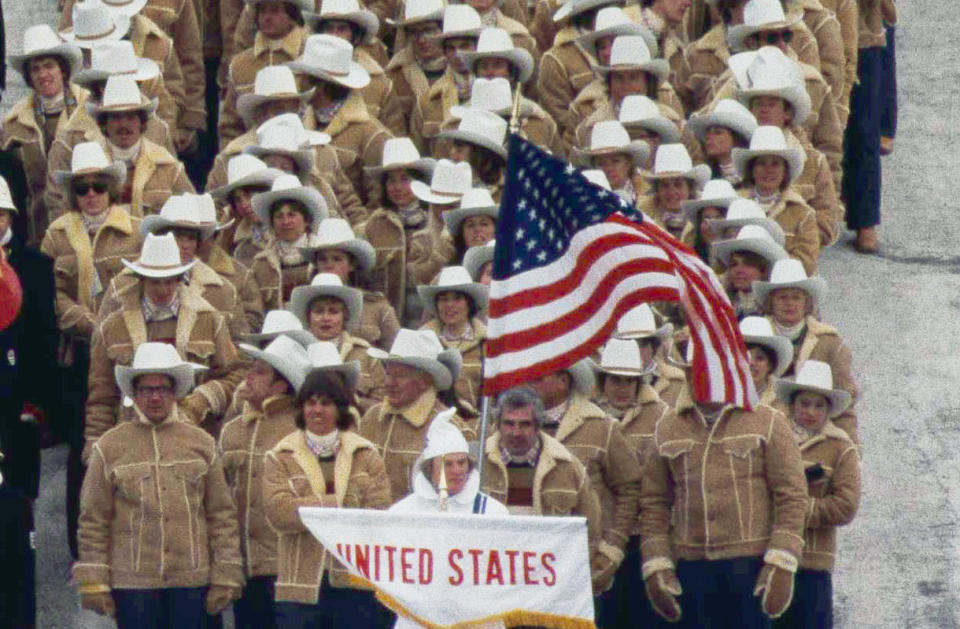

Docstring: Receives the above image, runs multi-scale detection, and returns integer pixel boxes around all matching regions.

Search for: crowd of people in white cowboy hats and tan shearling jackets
[0,0,897,629]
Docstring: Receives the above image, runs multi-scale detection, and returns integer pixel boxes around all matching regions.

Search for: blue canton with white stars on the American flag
[494,135,642,279]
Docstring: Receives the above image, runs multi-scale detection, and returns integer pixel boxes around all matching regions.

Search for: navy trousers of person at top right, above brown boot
[841,48,883,229]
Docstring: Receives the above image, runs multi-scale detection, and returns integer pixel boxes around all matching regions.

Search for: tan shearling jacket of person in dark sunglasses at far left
[40,205,143,340]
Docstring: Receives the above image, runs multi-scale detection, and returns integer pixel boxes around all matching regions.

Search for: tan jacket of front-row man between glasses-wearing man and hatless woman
[218,395,298,577]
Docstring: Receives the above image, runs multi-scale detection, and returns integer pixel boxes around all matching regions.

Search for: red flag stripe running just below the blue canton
[490,228,673,319]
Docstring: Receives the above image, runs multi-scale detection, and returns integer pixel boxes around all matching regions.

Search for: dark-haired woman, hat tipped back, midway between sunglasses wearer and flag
[250,175,327,310]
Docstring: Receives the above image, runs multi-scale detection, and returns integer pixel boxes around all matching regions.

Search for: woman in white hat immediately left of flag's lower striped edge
[417,266,487,408]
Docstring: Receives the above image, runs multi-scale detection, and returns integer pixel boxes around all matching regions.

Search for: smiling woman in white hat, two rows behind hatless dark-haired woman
[290,272,384,412]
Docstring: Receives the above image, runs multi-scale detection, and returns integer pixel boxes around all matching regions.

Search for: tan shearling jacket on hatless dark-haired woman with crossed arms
[263,430,390,605]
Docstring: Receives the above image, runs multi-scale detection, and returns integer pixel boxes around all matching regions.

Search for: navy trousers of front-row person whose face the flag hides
[672,557,770,629]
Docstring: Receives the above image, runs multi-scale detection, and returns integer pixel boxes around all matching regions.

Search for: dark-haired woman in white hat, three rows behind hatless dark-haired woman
[303,219,400,348]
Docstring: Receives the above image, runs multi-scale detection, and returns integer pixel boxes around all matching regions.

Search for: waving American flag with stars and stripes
[484,135,756,408]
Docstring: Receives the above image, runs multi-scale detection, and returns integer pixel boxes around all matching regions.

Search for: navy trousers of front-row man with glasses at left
[113,586,222,629]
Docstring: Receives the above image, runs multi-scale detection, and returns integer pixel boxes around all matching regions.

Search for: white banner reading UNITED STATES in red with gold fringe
[300,507,594,629]
